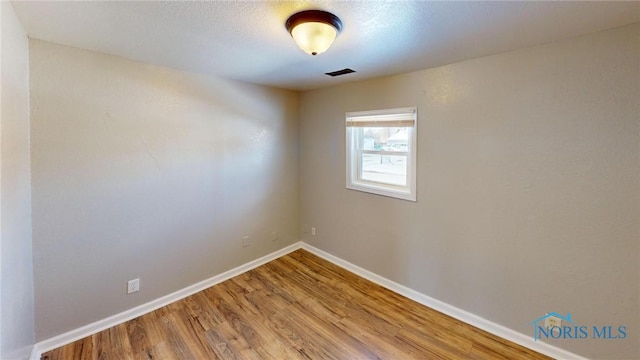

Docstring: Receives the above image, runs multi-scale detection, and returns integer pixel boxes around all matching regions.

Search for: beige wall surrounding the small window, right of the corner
[300,24,640,359]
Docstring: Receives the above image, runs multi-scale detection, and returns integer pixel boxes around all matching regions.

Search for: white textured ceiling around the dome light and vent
[13,1,640,90]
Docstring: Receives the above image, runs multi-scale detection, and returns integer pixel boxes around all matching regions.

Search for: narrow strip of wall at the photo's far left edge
[0,1,34,360]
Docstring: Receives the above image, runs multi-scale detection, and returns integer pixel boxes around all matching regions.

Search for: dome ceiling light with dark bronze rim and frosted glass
[285,10,342,55]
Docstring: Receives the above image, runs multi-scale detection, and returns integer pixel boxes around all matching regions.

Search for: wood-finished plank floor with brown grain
[42,250,549,360]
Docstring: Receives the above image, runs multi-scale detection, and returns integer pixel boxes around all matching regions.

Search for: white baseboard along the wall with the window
[302,243,587,360]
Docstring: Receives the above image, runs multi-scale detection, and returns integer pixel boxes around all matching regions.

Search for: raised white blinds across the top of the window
[346,107,417,127]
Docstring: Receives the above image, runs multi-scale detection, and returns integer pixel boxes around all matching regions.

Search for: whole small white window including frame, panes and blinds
[345,107,417,201]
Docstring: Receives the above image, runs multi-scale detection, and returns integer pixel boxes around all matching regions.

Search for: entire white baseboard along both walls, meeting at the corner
[30,242,587,360]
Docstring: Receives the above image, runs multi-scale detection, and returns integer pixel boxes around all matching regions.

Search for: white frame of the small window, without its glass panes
[345,107,418,201]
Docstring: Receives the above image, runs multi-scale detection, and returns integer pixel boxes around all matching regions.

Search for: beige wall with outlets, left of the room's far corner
[30,40,300,340]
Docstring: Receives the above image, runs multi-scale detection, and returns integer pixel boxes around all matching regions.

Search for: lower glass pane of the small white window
[360,154,407,186]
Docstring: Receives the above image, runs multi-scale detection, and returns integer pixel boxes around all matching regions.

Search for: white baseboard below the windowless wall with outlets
[30,242,302,360]
